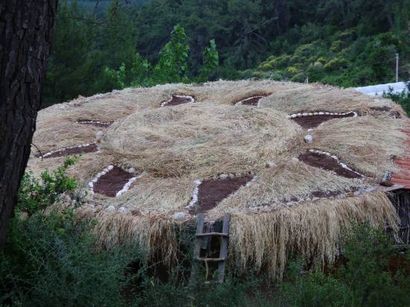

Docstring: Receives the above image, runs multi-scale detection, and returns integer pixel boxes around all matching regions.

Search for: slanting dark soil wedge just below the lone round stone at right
[299,151,361,178]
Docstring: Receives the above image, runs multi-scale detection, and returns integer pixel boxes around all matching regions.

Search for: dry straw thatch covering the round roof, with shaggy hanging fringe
[29,81,408,278]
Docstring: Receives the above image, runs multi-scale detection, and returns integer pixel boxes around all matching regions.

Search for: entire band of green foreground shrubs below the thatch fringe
[0,160,410,306]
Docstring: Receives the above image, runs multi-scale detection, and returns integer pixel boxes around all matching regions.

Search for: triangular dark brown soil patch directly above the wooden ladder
[197,176,252,212]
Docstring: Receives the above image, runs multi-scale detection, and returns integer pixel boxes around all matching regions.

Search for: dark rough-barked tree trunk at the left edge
[0,0,57,247]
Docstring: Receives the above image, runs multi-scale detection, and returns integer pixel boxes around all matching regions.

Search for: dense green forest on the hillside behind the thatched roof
[44,0,410,105]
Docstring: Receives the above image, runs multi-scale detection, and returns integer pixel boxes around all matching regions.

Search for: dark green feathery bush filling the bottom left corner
[0,210,137,306]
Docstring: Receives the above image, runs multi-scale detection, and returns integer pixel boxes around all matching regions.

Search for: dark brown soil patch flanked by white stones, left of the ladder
[94,166,133,197]
